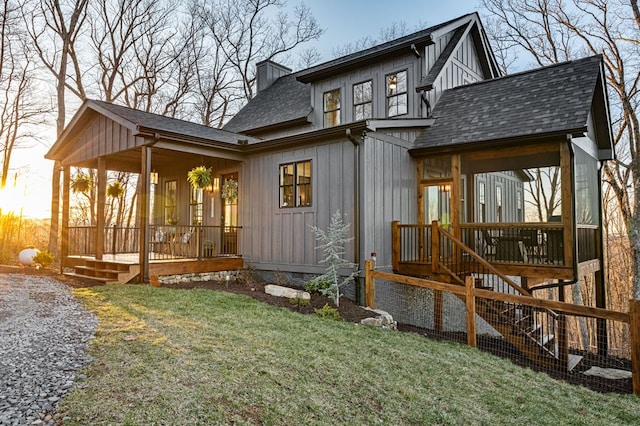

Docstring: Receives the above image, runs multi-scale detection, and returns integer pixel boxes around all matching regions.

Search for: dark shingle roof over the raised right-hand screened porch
[414,56,601,151]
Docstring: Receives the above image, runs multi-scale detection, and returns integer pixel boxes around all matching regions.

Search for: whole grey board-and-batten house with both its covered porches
[46,13,613,366]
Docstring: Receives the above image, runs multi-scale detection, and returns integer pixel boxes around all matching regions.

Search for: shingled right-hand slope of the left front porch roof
[87,99,246,144]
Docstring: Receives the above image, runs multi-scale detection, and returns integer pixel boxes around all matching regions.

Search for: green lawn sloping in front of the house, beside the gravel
[59,285,640,425]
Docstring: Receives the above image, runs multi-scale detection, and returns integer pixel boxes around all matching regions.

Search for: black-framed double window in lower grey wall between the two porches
[280,160,311,208]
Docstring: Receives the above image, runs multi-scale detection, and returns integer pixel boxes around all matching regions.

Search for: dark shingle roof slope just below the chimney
[223,74,311,133]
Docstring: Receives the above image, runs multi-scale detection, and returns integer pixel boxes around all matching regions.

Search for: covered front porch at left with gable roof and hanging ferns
[47,100,252,282]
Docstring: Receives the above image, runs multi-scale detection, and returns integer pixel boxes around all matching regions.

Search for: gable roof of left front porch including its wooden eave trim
[45,99,257,159]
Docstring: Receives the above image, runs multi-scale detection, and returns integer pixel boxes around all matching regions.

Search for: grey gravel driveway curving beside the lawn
[0,274,97,425]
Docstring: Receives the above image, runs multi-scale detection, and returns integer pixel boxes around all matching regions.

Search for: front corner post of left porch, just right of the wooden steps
[138,146,151,283]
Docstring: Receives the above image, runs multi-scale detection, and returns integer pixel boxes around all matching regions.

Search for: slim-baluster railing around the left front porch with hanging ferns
[68,225,242,259]
